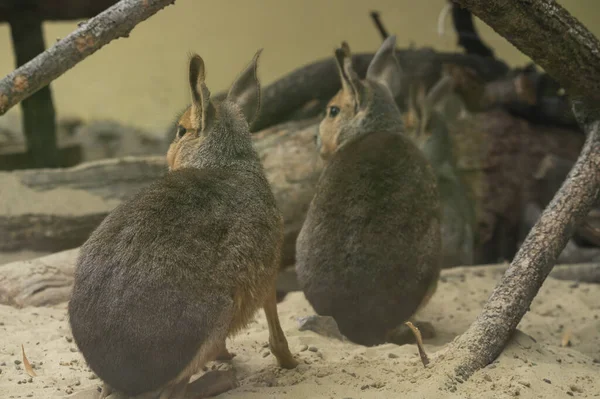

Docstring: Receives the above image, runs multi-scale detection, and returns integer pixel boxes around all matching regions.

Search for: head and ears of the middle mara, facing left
[317,36,402,159]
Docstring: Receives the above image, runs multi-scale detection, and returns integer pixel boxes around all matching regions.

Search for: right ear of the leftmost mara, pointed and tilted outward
[227,49,262,125]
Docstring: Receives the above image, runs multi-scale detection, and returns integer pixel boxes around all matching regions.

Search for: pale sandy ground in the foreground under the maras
[0,268,600,399]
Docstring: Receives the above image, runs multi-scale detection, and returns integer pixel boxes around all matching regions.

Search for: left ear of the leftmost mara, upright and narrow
[189,54,213,131]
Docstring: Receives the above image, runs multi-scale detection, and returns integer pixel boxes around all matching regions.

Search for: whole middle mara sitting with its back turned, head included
[296,36,441,345]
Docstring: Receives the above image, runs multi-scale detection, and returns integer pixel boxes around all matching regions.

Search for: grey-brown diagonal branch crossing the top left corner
[0,0,175,115]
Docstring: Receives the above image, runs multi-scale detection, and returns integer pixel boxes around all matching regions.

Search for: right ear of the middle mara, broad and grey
[366,35,402,98]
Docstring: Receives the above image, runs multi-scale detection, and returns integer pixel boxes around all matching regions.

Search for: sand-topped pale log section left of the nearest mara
[0,157,166,252]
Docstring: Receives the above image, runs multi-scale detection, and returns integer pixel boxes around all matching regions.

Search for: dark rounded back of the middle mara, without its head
[297,132,440,345]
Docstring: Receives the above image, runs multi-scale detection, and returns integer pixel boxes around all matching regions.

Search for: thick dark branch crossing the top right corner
[454,0,600,102]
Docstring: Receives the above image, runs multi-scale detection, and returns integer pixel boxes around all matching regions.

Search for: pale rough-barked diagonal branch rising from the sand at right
[450,97,600,378]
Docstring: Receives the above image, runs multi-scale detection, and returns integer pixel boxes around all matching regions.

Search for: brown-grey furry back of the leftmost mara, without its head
[69,168,281,395]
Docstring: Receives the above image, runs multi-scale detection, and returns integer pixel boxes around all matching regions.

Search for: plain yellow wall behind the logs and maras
[0,0,600,130]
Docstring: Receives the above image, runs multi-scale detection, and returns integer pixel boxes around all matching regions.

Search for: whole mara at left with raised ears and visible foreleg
[69,53,297,398]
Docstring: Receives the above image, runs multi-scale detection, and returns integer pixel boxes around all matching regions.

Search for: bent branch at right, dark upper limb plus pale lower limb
[442,0,600,379]
